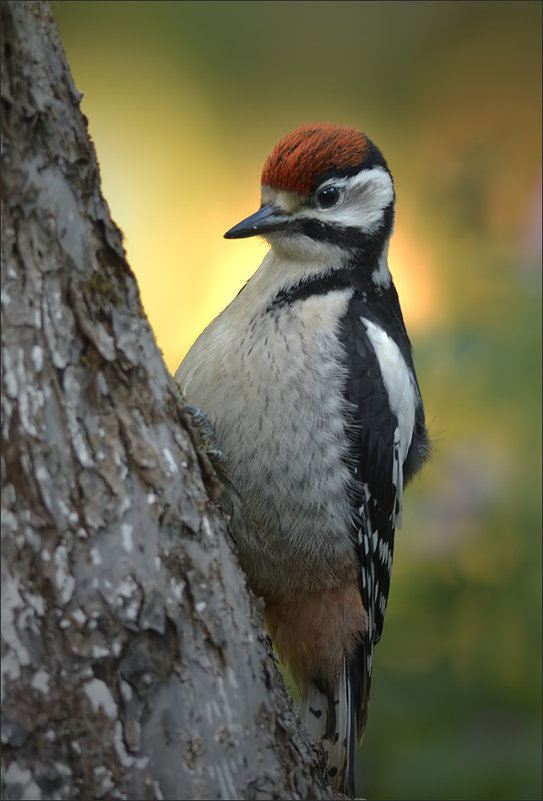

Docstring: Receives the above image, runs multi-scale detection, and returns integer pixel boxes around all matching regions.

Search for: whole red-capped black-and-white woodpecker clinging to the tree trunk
[176,123,429,795]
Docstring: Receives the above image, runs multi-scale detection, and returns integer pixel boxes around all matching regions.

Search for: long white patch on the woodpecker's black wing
[361,317,418,528]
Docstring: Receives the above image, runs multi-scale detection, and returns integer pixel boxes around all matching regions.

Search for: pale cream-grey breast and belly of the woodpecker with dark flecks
[180,290,357,600]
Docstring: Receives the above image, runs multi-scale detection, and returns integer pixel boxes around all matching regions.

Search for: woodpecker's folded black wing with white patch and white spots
[341,294,420,733]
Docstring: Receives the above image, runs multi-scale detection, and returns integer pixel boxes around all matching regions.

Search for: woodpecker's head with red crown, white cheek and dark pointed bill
[225,123,395,266]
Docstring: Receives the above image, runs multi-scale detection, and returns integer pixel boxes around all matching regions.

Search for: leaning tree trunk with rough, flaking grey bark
[2,1,342,799]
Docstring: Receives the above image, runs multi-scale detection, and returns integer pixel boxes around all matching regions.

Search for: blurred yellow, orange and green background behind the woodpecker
[52,0,542,800]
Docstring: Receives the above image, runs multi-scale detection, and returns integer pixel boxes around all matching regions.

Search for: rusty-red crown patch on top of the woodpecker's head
[261,123,369,195]
